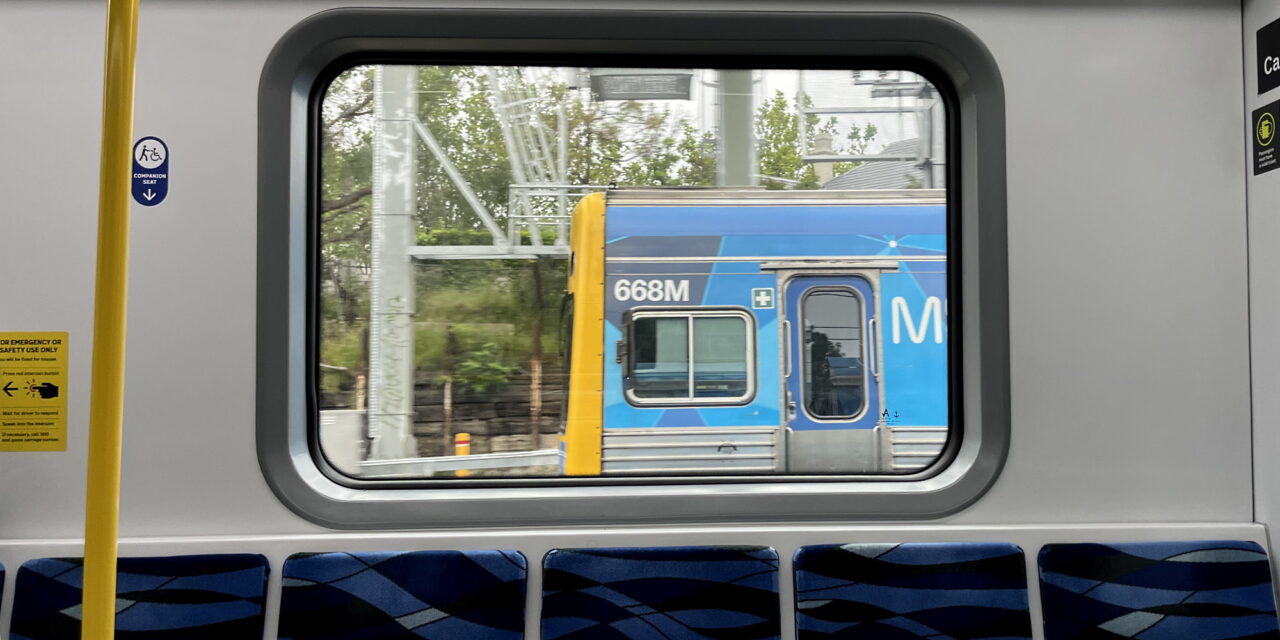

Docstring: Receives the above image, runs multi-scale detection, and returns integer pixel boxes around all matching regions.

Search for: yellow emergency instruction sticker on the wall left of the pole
[0,332,68,452]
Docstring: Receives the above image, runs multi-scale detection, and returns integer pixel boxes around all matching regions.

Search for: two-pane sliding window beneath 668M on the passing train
[622,311,754,404]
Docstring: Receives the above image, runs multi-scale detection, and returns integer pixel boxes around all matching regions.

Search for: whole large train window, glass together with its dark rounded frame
[259,9,1007,526]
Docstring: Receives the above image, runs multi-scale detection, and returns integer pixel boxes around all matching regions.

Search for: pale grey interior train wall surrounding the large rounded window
[0,0,1280,637]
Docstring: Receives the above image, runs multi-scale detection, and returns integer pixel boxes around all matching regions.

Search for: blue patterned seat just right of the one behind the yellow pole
[279,550,527,640]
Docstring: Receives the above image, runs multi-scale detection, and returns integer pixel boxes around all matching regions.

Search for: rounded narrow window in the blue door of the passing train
[800,288,867,420]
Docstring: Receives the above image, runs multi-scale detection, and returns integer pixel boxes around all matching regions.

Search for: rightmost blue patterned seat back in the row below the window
[1039,540,1280,640]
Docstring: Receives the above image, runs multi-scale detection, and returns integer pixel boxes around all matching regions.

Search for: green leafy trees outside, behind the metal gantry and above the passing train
[319,67,876,404]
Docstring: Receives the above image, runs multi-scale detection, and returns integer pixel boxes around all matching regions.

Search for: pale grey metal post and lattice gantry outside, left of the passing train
[362,67,586,474]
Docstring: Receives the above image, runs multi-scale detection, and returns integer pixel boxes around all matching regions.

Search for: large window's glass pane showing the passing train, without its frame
[315,64,955,480]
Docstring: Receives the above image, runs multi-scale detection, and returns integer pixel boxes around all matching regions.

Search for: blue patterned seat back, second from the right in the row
[795,543,1032,640]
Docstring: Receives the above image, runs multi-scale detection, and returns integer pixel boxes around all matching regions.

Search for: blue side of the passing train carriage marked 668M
[567,189,947,474]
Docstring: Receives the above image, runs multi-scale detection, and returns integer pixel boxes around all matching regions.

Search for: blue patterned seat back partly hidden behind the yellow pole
[10,554,268,640]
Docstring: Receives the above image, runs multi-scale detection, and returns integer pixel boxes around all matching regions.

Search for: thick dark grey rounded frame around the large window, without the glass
[256,9,1010,529]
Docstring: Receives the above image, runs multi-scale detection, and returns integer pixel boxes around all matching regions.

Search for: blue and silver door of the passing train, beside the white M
[783,274,883,472]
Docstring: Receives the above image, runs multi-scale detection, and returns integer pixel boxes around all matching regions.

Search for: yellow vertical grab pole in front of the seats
[81,0,138,640]
